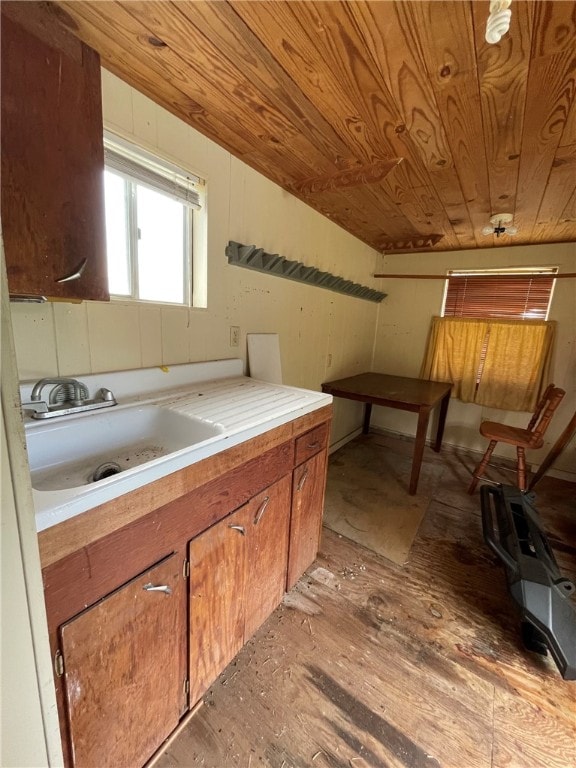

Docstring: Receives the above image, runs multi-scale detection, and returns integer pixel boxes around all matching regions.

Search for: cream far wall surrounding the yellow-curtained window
[372,243,576,480]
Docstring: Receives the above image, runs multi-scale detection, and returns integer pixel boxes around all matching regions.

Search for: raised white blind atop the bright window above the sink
[104,137,202,210]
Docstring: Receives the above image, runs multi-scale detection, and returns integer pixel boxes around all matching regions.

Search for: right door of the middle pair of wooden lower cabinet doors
[244,475,291,642]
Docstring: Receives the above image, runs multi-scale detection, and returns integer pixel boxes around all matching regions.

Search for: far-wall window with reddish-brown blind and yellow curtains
[421,269,556,411]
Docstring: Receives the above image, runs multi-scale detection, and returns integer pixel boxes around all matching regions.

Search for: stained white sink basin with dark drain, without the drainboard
[26,405,222,491]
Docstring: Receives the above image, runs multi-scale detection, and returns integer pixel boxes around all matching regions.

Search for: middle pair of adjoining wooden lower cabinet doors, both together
[189,475,290,704]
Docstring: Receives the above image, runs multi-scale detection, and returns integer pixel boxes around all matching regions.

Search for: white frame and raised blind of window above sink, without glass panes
[104,131,207,308]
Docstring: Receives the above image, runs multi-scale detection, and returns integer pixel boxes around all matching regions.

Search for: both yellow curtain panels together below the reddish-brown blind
[420,317,555,411]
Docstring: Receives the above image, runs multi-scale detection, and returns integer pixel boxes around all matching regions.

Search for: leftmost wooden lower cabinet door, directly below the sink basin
[60,555,181,768]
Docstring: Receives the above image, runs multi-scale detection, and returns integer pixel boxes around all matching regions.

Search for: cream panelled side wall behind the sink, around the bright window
[12,71,379,448]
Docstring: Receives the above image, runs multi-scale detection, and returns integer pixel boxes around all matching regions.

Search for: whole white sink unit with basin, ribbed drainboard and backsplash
[20,359,332,532]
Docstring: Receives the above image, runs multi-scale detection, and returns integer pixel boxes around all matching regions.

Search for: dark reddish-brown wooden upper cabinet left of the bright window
[1,8,109,300]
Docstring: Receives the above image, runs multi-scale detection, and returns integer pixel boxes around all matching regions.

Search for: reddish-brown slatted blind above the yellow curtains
[443,272,554,320]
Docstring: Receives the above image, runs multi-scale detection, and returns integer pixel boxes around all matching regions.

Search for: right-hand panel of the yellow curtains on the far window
[475,320,555,411]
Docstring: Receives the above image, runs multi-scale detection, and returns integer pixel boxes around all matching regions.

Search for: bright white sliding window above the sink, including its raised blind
[104,135,203,305]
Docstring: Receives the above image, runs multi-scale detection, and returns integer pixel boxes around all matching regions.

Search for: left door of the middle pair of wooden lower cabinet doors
[189,505,251,705]
